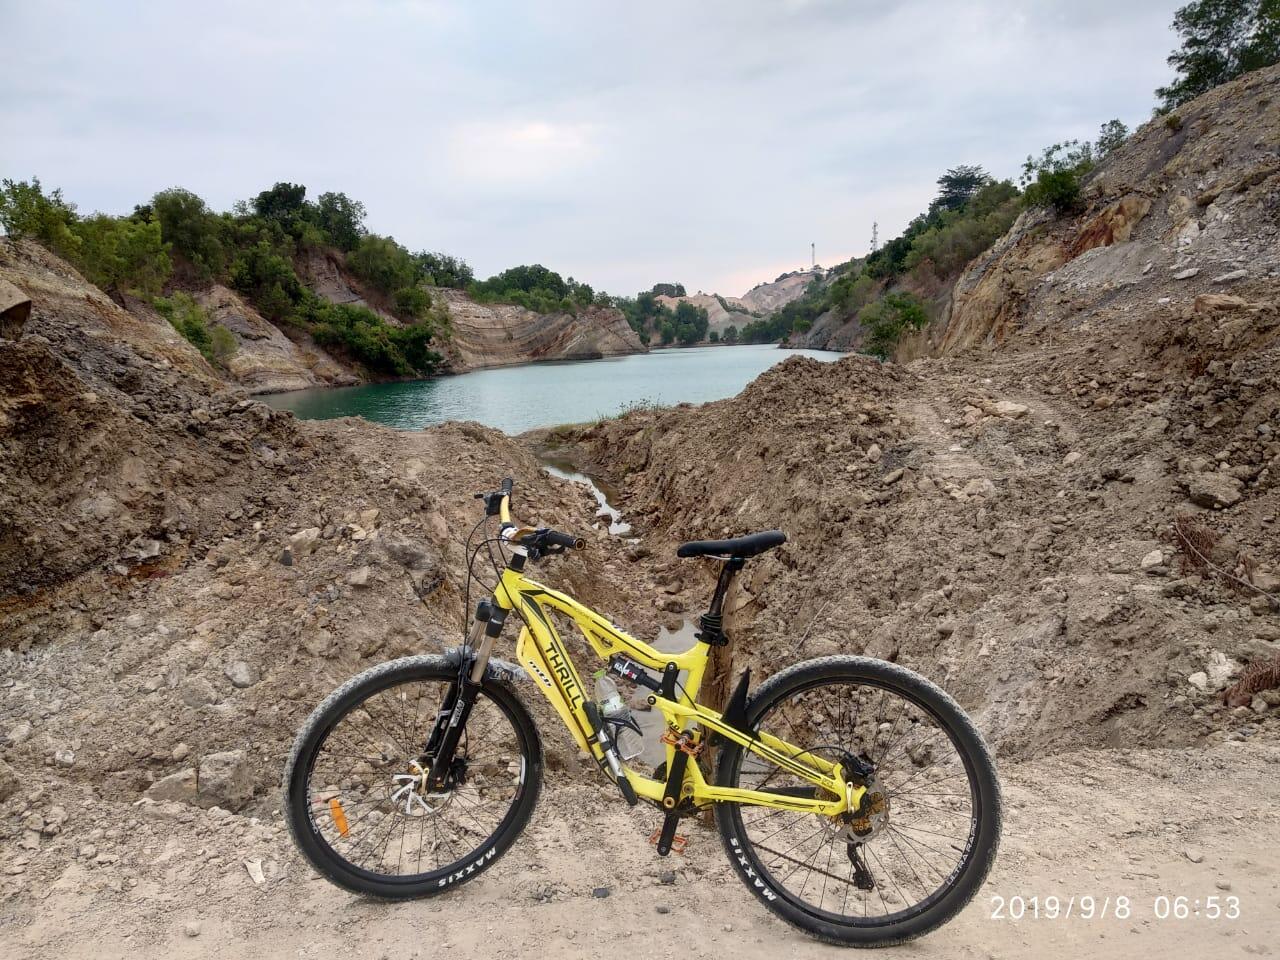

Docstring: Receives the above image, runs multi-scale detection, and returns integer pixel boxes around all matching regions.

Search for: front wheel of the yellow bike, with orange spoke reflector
[284,657,543,900]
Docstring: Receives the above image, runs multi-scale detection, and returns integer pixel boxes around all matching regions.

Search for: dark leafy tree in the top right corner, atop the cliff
[1156,0,1280,113]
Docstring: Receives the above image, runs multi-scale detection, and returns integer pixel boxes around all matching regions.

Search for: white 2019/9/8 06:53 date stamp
[989,893,1240,923]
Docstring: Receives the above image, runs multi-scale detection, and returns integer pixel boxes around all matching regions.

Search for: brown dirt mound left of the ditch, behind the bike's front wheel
[0,239,654,865]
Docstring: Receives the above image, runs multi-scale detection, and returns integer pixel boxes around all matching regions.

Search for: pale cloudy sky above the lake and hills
[0,0,1183,296]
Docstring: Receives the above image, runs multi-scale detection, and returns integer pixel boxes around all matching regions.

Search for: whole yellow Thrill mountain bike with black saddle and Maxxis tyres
[284,480,1000,946]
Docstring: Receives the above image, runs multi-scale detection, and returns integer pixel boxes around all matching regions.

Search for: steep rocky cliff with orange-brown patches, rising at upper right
[931,67,1280,353]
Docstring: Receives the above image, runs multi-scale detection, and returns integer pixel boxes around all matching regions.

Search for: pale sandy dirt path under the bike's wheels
[0,744,1280,960]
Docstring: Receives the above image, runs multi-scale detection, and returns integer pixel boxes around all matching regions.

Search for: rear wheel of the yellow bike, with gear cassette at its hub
[716,657,1001,946]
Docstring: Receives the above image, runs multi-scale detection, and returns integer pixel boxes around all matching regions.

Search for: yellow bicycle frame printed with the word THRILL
[493,567,867,817]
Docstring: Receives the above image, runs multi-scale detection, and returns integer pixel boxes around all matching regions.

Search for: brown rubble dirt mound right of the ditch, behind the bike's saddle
[571,304,1280,755]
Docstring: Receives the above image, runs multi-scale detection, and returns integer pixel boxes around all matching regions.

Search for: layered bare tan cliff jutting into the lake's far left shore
[433,289,645,372]
